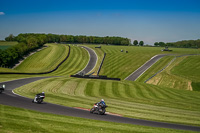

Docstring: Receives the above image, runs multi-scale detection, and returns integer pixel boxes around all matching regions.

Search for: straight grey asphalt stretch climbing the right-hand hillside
[125,54,166,81]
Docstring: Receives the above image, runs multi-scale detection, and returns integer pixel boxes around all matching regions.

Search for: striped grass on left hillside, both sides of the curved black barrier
[0,44,89,82]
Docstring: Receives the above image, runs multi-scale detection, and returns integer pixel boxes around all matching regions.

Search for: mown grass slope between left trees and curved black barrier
[15,44,69,73]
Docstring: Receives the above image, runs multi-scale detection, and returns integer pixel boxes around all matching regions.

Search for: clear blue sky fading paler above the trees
[0,0,200,45]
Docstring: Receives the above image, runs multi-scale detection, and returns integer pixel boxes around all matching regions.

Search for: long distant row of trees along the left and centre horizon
[5,33,131,46]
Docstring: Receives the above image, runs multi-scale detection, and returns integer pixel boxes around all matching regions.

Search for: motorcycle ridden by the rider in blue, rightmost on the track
[90,103,108,115]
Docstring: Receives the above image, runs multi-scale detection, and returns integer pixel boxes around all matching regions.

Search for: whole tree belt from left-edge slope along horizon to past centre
[0,33,131,67]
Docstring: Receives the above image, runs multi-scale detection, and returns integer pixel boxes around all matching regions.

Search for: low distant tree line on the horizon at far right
[154,39,200,48]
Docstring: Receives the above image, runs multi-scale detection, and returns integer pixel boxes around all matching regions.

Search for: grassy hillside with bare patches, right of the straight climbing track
[137,55,200,91]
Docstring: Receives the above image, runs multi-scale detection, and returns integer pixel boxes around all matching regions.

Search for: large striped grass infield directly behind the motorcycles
[14,78,200,126]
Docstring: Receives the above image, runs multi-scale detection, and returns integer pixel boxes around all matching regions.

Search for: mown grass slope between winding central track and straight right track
[100,46,164,79]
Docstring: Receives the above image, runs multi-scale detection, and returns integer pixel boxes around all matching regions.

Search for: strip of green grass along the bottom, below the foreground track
[0,105,191,133]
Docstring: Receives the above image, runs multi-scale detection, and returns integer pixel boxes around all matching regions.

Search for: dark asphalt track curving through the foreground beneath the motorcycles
[0,48,200,131]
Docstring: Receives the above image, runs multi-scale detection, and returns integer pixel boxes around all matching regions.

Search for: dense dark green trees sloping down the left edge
[0,34,46,67]
